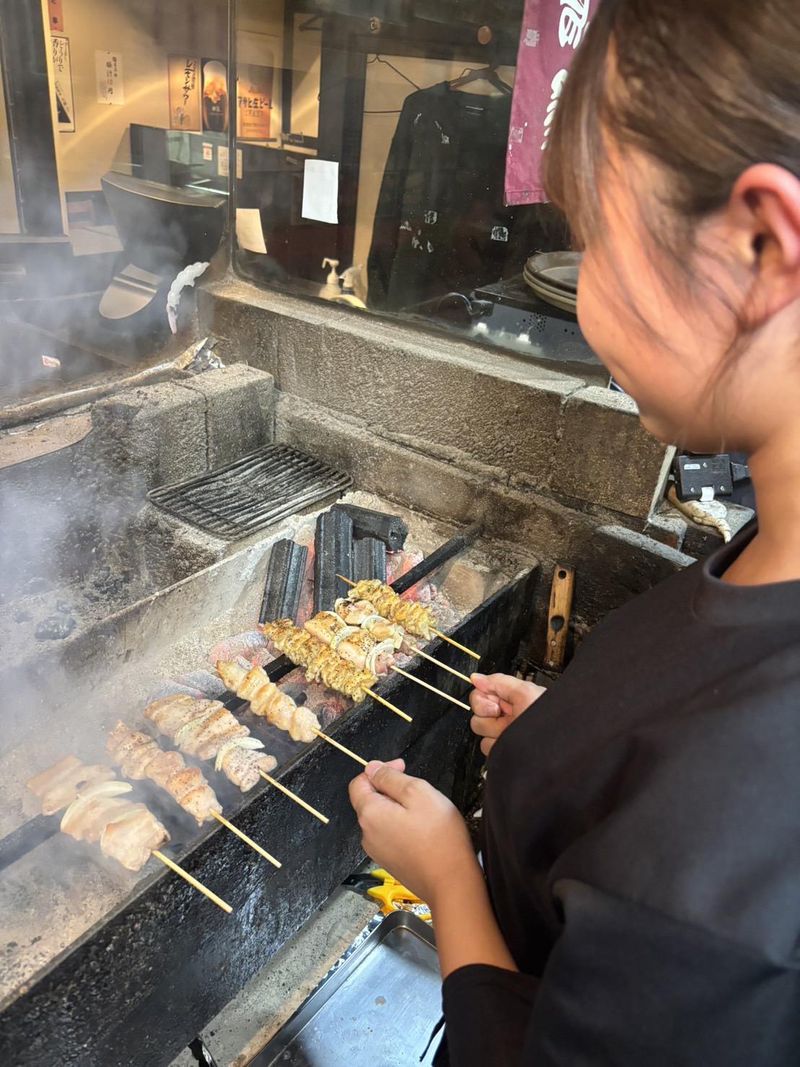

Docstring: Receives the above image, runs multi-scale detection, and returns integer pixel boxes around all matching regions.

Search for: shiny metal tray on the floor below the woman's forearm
[251,911,442,1067]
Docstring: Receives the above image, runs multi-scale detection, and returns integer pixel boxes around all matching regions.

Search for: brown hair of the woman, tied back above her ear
[545,0,800,250]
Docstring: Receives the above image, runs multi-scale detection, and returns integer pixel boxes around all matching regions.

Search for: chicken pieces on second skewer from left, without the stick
[107,722,222,825]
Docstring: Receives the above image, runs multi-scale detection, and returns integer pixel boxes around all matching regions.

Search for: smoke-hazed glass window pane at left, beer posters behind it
[0,0,229,404]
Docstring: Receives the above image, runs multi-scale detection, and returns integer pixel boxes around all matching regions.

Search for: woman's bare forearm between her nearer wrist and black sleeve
[428,857,517,980]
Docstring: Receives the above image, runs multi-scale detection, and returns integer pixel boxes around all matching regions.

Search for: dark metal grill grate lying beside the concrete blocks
[147,445,353,541]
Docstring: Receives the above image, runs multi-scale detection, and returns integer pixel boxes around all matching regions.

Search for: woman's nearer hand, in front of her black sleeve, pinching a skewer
[350,760,478,907]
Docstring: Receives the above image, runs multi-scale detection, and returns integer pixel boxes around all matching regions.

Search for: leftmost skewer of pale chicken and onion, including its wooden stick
[28,755,234,913]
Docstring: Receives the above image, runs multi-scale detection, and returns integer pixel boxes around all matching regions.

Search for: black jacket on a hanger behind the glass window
[368,82,532,310]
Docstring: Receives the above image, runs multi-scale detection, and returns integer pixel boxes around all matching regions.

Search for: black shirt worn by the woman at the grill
[444,532,800,1067]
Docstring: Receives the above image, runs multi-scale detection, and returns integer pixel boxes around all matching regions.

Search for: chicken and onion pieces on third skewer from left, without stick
[144,692,277,793]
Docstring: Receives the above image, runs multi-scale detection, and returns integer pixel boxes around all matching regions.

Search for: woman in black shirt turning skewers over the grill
[351,0,800,1067]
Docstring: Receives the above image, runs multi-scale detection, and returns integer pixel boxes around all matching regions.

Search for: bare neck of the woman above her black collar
[722,419,800,586]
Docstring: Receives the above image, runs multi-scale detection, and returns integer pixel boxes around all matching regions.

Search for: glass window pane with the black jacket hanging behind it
[236,0,592,360]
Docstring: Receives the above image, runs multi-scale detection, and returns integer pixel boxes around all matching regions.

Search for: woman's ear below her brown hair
[729,163,800,325]
